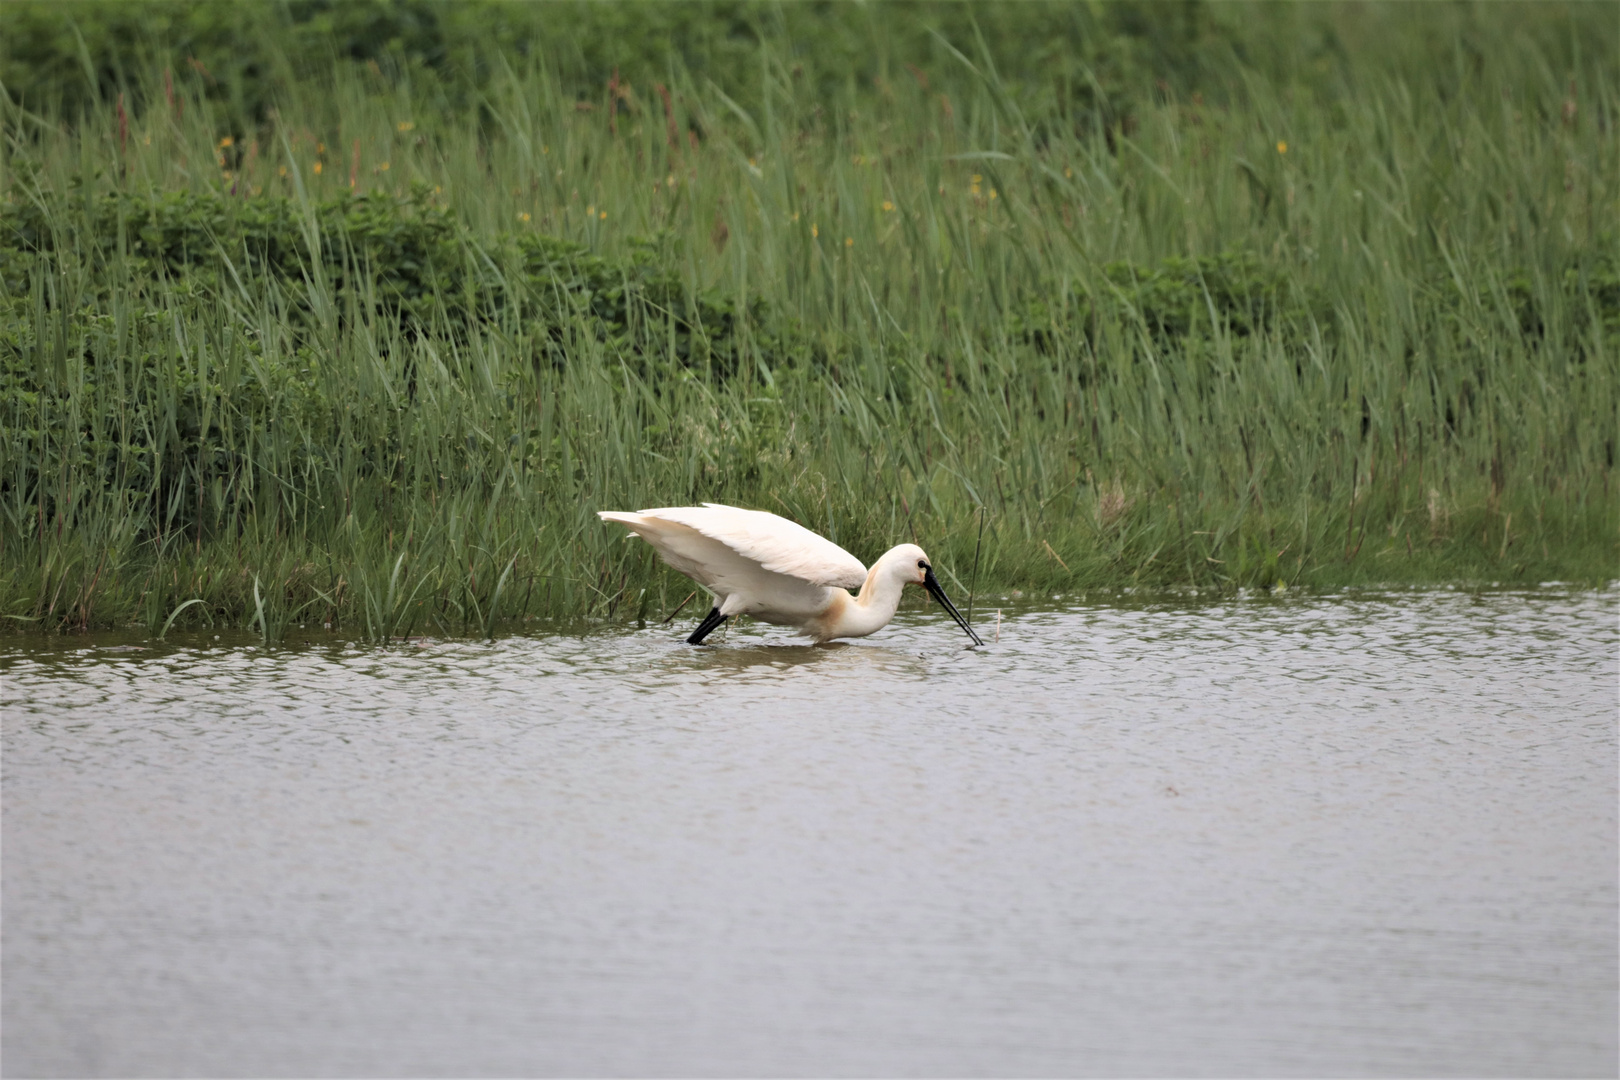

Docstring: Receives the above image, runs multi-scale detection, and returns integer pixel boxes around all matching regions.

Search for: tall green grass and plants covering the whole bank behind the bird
[0,2,1620,638]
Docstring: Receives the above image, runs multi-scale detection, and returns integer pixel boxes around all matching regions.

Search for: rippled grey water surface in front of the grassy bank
[0,589,1620,1077]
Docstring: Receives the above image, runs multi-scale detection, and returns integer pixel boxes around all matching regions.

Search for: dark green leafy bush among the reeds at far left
[0,191,782,544]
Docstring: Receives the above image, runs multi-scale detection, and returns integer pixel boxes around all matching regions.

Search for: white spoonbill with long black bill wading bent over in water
[599,502,983,644]
